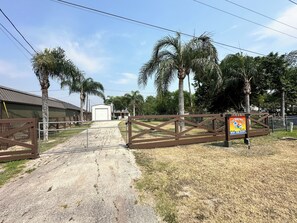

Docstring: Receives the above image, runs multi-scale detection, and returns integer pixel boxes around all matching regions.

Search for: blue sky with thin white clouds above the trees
[0,0,297,108]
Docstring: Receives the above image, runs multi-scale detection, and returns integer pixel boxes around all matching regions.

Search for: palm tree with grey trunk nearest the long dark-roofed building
[31,47,73,141]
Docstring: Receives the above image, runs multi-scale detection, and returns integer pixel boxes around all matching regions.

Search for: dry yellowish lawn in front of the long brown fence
[135,136,297,223]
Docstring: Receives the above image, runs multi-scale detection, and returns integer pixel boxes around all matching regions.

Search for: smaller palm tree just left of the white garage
[61,68,104,121]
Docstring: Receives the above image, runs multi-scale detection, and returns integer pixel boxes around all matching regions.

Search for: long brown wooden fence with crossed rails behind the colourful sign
[127,113,269,149]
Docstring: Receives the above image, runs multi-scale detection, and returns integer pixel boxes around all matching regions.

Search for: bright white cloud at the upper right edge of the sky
[252,5,297,48]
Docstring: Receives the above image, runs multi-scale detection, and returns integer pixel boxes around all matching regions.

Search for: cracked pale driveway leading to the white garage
[0,122,157,223]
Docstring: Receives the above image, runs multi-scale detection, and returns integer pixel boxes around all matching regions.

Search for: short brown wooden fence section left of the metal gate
[0,118,39,162]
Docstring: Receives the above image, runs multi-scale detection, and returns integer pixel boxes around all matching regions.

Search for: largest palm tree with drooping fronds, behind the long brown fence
[138,34,219,118]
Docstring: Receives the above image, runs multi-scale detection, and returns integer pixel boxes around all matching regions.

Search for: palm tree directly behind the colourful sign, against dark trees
[221,53,258,113]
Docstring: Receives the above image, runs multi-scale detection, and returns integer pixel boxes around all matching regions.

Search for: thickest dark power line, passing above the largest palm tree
[50,0,264,56]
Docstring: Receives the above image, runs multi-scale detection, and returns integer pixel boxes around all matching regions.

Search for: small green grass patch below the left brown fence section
[0,160,26,187]
